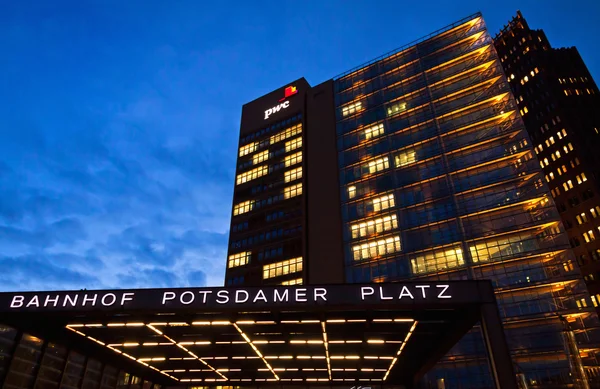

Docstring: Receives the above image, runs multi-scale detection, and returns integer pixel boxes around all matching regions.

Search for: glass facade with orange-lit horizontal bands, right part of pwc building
[335,15,598,388]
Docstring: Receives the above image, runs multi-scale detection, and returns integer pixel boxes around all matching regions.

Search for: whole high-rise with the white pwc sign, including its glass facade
[226,14,600,388]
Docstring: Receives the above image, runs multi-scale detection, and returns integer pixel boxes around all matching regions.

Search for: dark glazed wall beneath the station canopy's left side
[0,324,161,389]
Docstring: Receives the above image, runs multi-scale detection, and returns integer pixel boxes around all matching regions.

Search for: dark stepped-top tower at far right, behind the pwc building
[494,12,600,316]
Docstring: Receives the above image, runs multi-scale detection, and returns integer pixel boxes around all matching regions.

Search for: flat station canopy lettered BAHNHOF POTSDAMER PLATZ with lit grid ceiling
[0,281,513,387]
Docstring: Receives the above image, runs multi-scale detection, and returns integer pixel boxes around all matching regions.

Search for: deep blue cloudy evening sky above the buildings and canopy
[0,0,600,291]
